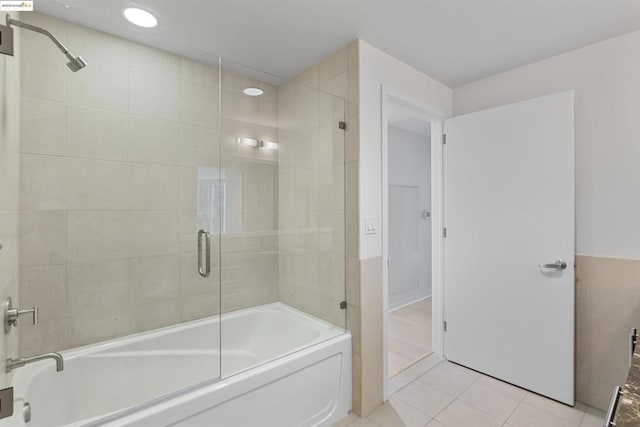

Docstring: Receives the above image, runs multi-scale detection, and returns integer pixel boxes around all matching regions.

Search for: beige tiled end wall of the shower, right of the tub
[278,40,362,414]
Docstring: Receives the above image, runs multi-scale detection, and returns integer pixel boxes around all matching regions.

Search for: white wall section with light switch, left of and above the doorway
[359,41,452,259]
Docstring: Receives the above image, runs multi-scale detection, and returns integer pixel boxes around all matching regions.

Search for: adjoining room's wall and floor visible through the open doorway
[387,111,432,378]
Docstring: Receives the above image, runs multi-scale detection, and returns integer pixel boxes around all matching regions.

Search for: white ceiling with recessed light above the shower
[34,0,640,87]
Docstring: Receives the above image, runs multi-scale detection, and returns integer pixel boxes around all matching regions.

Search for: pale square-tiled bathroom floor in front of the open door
[336,355,604,427]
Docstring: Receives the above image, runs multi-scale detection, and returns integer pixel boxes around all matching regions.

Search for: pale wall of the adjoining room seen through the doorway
[388,126,431,308]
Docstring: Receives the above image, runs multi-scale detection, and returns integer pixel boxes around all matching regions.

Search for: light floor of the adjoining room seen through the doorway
[387,298,432,377]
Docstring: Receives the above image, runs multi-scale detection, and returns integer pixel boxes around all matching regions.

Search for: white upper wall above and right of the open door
[453,31,640,259]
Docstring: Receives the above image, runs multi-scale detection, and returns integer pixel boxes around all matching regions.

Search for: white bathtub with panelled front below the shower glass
[5,303,351,427]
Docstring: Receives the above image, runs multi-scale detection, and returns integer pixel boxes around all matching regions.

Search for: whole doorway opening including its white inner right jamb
[382,89,442,397]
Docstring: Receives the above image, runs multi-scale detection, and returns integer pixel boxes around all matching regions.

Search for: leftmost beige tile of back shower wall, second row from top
[20,96,67,156]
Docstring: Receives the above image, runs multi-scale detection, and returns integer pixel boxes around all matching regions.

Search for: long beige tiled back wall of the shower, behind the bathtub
[18,13,277,355]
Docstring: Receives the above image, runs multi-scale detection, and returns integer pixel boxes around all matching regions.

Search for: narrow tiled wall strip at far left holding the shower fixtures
[0,13,20,388]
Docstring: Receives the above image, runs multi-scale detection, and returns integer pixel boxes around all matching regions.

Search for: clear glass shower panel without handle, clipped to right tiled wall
[220,58,346,378]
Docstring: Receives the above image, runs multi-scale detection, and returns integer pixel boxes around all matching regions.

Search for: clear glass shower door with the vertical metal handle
[11,13,224,425]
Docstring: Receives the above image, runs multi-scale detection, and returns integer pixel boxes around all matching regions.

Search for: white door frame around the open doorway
[381,85,448,401]
